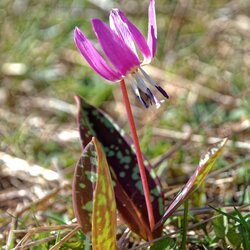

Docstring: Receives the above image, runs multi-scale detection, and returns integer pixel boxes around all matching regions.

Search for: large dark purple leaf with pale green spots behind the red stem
[76,97,164,240]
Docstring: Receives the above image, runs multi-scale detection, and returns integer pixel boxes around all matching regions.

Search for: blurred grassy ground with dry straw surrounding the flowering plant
[0,0,250,249]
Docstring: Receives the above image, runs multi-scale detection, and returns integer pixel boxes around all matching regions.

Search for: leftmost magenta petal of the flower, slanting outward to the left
[74,27,121,81]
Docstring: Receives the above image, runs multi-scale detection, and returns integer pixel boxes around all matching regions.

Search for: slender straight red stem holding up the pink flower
[120,80,155,231]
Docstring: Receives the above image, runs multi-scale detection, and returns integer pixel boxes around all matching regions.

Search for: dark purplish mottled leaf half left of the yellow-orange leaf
[72,141,97,235]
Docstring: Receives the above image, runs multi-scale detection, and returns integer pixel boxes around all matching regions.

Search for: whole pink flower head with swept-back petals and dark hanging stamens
[74,0,168,108]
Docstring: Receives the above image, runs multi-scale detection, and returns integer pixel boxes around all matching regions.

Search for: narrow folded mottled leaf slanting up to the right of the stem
[155,139,227,228]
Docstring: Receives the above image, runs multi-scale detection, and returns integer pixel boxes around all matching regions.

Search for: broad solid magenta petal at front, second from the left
[92,19,140,76]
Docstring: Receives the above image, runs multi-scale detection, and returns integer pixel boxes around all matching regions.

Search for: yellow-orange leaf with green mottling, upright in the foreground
[92,138,117,250]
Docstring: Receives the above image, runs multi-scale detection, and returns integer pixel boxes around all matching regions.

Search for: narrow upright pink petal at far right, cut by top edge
[148,0,157,58]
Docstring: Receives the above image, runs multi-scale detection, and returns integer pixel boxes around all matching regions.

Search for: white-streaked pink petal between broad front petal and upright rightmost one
[110,9,151,63]
